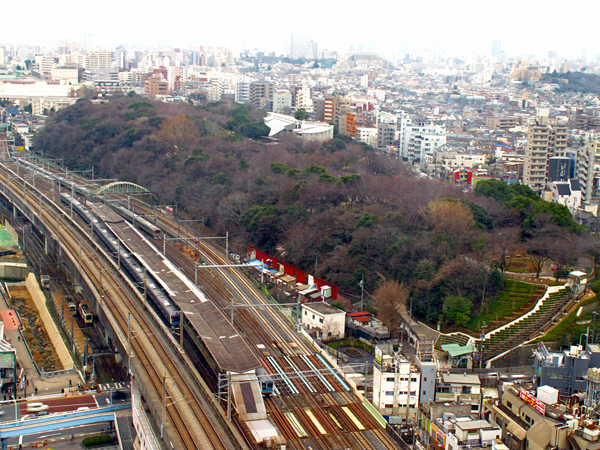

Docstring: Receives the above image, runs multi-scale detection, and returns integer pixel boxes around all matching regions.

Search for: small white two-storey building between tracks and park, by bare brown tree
[302,302,346,342]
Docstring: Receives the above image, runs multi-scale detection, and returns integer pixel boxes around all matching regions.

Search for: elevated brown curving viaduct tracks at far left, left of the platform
[0,163,233,450]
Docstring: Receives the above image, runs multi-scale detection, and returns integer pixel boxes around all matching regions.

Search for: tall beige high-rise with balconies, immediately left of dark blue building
[523,108,568,194]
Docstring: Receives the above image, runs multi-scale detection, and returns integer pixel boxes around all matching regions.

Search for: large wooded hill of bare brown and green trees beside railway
[34,97,598,338]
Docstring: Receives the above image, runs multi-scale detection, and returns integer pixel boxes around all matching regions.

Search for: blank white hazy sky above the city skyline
[0,0,600,58]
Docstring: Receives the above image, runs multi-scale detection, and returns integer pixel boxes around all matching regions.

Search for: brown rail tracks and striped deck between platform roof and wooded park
[9,157,397,450]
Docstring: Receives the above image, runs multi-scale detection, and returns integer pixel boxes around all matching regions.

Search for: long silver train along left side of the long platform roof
[60,193,179,327]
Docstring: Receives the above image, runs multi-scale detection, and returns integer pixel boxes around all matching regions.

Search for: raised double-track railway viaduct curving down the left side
[0,156,240,450]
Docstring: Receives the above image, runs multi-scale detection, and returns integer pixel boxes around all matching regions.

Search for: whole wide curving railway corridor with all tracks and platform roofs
[0,149,406,450]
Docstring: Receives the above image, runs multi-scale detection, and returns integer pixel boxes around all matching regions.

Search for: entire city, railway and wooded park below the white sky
[0,33,600,450]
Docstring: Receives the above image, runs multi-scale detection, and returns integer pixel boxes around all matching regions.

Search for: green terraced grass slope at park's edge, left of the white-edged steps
[467,279,543,332]
